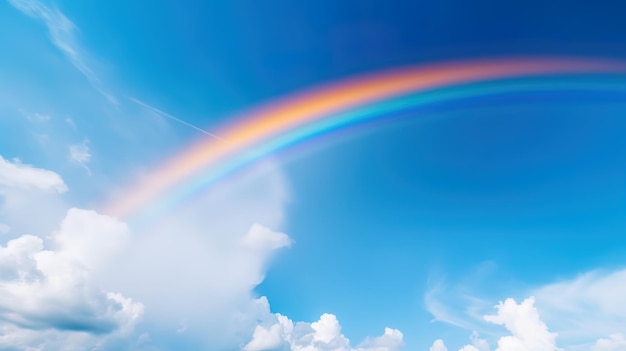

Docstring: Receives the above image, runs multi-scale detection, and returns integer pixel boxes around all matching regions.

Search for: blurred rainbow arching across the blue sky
[103,58,626,223]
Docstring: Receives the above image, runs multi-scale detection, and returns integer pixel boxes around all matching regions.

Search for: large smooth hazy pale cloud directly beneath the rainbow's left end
[94,163,292,349]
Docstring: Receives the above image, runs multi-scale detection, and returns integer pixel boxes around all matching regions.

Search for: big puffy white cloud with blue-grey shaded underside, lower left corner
[0,209,143,350]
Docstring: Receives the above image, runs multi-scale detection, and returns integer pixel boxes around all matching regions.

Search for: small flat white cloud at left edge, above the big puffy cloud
[0,156,67,193]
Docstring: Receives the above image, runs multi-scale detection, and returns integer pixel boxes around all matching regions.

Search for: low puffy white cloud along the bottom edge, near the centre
[243,313,404,351]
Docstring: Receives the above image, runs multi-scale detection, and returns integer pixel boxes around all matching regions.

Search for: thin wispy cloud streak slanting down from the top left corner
[8,0,118,105]
